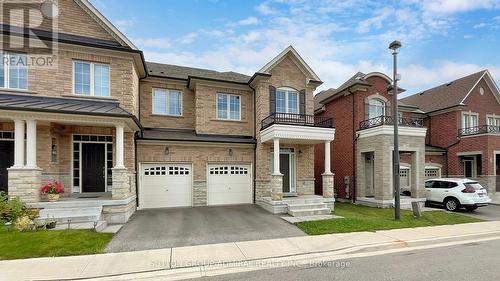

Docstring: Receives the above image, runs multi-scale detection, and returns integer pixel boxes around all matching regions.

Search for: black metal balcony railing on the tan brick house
[261,113,334,130]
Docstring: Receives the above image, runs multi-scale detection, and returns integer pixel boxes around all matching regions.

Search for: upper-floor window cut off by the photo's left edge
[0,53,28,90]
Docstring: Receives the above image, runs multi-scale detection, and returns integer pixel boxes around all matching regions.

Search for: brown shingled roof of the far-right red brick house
[402,70,490,112]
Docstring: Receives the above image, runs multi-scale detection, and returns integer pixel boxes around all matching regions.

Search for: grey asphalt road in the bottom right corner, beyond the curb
[189,236,500,281]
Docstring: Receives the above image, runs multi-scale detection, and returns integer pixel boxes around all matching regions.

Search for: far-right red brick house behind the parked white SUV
[401,70,500,202]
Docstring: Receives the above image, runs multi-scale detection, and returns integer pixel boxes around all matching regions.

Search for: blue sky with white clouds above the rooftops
[91,0,500,96]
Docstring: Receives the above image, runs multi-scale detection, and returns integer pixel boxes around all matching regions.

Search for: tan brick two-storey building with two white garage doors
[0,0,335,227]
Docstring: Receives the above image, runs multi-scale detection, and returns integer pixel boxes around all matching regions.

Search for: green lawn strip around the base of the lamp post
[297,203,481,235]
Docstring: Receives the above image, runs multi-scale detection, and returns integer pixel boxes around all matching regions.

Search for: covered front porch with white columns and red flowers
[0,95,139,222]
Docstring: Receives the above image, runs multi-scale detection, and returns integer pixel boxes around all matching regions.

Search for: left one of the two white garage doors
[139,164,192,208]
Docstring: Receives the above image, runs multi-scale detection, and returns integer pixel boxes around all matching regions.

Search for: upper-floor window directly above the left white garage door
[153,89,182,116]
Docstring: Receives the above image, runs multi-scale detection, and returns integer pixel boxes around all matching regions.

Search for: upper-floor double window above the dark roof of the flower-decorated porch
[73,61,110,97]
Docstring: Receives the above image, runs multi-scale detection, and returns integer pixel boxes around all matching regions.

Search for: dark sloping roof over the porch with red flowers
[0,93,132,117]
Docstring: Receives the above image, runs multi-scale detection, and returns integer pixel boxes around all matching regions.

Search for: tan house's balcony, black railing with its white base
[260,113,335,144]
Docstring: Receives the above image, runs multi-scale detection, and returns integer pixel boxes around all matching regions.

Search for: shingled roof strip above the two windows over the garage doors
[146,62,251,84]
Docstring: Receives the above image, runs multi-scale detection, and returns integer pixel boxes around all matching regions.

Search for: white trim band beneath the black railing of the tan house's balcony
[260,124,335,143]
